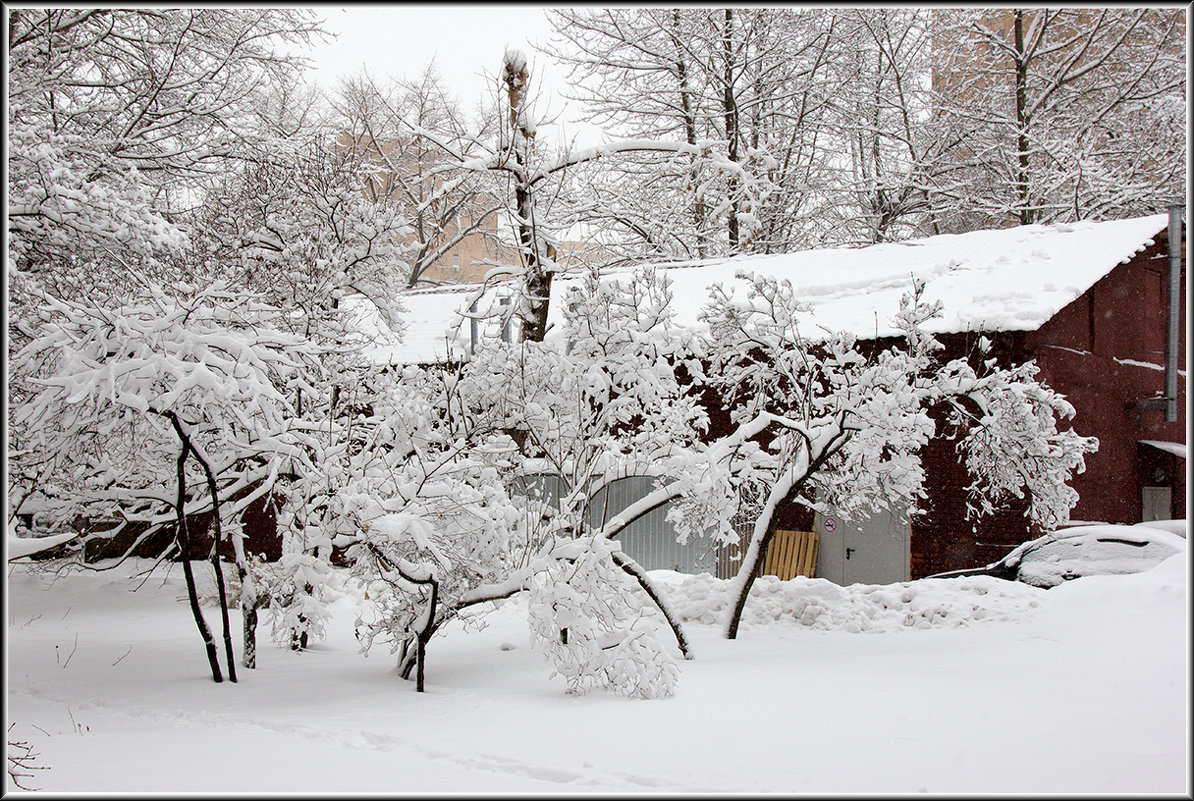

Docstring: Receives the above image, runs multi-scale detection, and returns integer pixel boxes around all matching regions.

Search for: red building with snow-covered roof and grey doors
[367,215,1186,584]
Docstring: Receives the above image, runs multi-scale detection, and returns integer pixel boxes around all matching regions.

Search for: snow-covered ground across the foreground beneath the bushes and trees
[6,554,1190,794]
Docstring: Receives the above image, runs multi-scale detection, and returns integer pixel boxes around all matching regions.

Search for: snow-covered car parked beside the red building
[929,520,1186,587]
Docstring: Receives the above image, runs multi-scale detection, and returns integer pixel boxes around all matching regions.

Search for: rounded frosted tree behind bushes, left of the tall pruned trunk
[183,76,413,348]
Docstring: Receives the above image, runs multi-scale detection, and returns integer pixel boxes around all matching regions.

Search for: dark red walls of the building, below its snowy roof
[910,225,1187,578]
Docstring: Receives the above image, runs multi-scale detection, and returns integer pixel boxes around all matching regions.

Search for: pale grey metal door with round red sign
[816,511,912,586]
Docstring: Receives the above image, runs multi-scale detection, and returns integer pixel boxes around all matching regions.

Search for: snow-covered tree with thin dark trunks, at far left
[10,281,319,680]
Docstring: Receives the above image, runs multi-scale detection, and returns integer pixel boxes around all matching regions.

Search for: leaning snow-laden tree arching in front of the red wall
[704,275,1097,637]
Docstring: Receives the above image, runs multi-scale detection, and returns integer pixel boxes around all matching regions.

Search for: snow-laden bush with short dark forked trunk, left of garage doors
[302,368,527,689]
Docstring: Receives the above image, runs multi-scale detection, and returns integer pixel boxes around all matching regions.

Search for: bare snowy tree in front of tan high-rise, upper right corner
[935,8,1186,229]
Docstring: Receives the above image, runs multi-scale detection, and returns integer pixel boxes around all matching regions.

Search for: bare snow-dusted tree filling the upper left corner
[7,8,320,288]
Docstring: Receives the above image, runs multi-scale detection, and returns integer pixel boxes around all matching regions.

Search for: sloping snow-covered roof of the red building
[351,215,1168,363]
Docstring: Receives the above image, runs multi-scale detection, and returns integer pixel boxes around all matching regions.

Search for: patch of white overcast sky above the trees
[306,4,599,144]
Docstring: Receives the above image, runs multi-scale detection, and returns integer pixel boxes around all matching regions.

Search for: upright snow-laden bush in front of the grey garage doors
[461,267,707,657]
